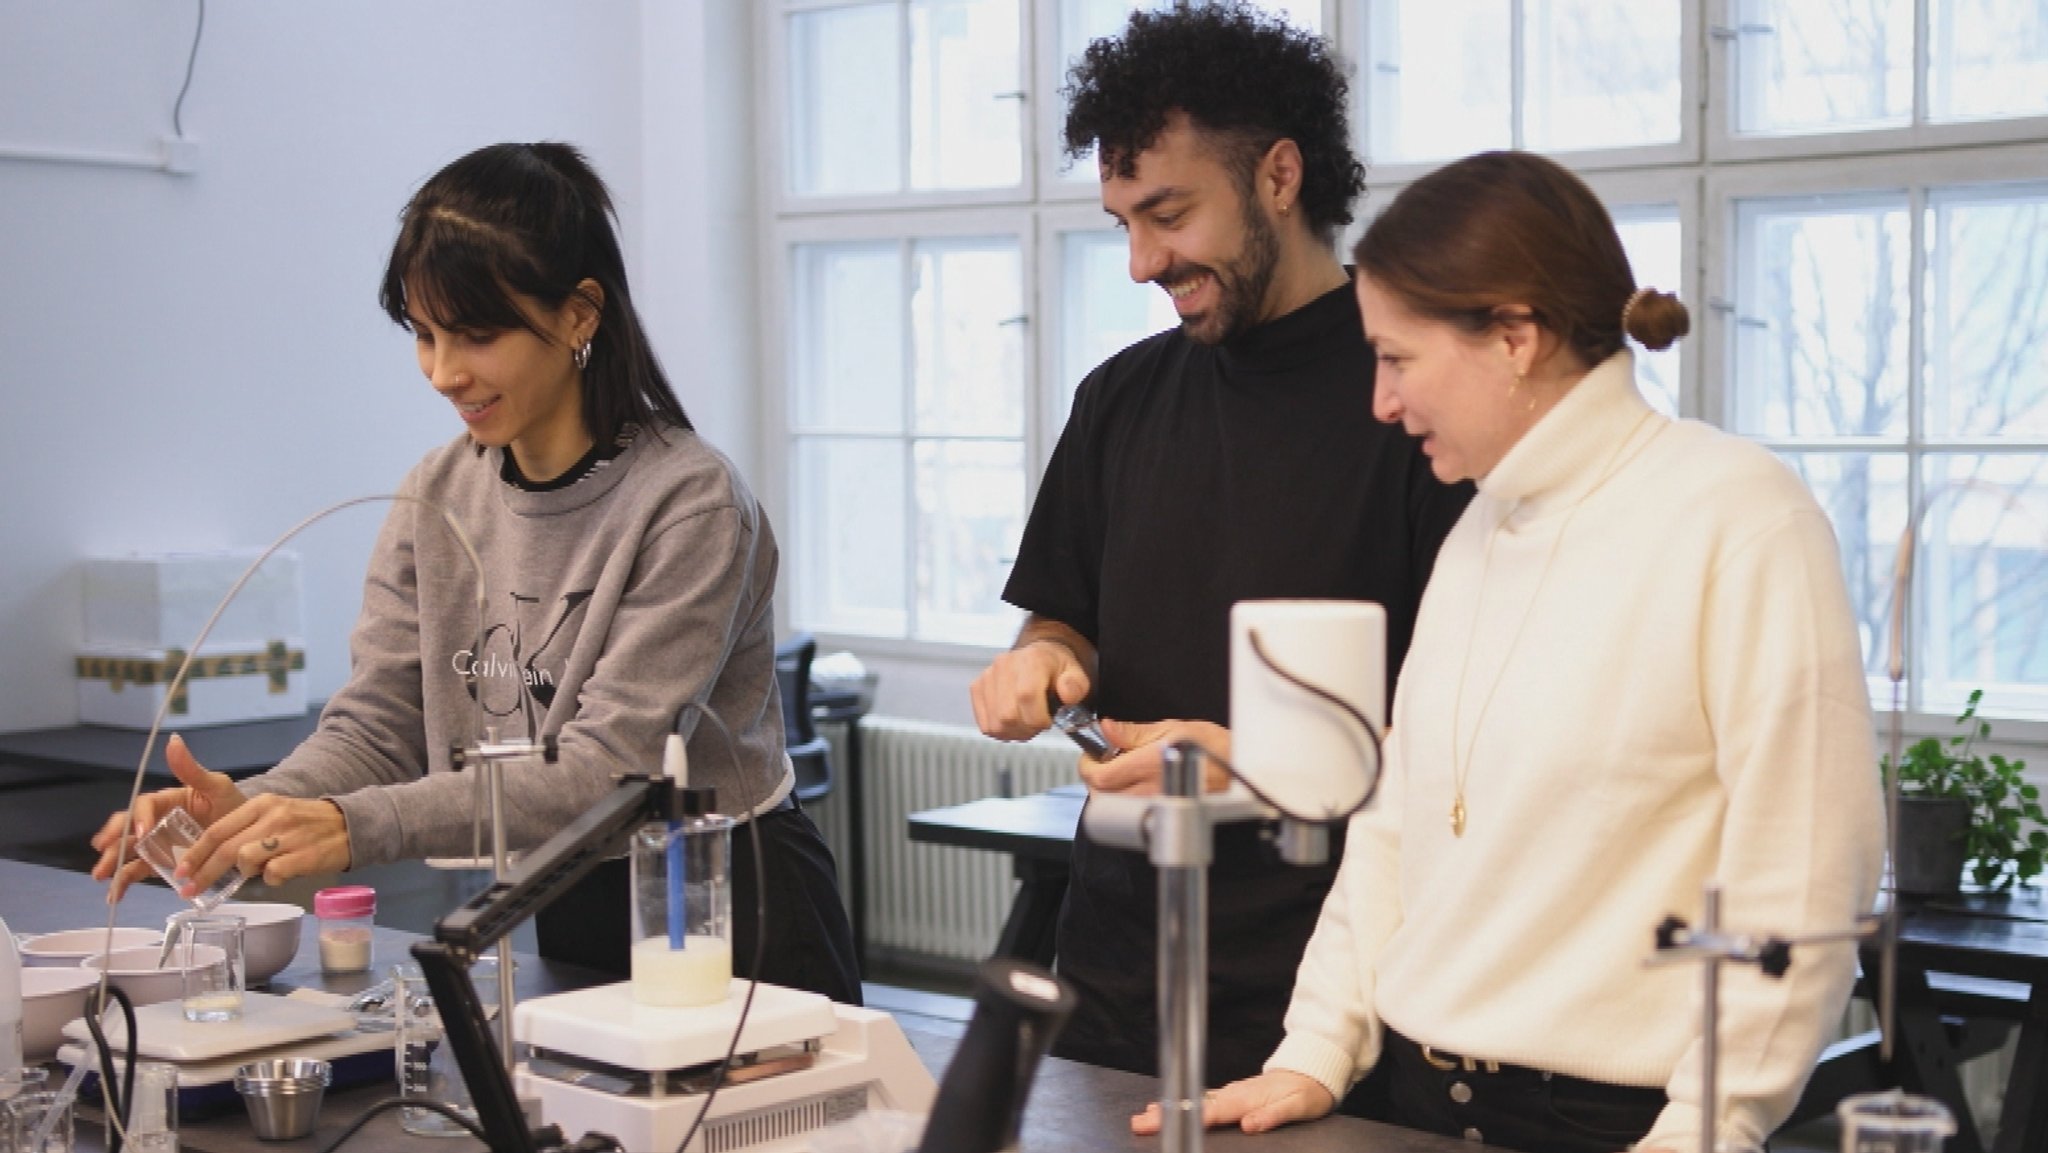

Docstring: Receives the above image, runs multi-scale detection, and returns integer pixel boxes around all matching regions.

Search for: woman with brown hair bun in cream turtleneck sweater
[1135,152,1882,1153]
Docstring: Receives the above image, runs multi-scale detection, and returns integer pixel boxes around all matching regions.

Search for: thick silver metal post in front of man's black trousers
[1153,743,1210,1153]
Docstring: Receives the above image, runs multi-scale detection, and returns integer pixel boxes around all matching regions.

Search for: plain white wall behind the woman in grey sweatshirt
[0,0,758,731]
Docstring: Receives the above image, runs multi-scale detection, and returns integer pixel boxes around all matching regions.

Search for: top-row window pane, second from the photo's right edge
[1735,0,1913,133]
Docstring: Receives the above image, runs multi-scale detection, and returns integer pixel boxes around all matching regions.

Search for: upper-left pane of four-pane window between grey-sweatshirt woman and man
[791,240,905,432]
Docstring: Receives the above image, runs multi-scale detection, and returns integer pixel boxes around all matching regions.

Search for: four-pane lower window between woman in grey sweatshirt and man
[788,223,1028,645]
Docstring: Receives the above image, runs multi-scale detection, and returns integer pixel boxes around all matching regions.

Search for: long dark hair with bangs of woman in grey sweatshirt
[377,143,692,444]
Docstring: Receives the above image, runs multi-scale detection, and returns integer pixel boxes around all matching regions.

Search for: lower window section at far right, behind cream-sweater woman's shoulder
[1726,167,2048,715]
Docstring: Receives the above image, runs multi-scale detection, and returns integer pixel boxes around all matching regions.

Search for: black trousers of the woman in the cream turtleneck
[1346,1030,1667,1153]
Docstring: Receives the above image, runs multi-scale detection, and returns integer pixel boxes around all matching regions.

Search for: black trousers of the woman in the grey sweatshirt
[535,805,860,1006]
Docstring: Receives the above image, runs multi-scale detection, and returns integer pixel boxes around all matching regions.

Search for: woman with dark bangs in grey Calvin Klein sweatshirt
[92,143,860,1003]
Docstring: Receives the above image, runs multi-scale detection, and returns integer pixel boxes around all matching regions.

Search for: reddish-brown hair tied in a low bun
[1352,152,1692,367]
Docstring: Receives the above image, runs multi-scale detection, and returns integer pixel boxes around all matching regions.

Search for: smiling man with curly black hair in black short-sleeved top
[973,4,1470,1085]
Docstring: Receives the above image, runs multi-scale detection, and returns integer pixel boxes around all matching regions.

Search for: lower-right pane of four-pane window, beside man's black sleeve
[915,440,1024,645]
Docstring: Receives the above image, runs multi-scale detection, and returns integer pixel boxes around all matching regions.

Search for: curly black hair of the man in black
[1061,0,1366,244]
